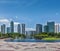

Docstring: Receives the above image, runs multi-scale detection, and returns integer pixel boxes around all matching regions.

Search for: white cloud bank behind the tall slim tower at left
[0,18,20,32]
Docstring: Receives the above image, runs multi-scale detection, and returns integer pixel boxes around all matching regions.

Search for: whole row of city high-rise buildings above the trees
[0,21,60,34]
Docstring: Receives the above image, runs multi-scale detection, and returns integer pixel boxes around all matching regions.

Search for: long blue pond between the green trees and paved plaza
[5,39,60,42]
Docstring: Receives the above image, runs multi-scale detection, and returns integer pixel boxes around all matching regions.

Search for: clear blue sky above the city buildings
[0,0,60,28]
